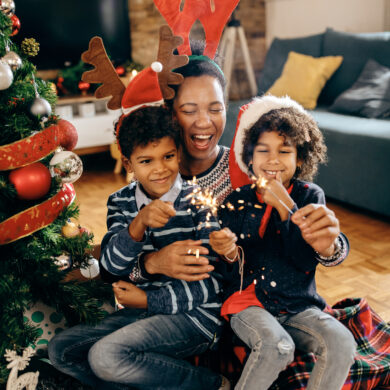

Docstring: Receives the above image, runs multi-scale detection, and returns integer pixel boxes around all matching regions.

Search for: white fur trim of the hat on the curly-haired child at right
[234,95,306,176]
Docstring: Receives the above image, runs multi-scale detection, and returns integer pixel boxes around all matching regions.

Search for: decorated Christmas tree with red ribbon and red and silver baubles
[0,0,109,388]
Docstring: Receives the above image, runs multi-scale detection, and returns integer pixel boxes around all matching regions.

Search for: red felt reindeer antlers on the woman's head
[153,0,240,60]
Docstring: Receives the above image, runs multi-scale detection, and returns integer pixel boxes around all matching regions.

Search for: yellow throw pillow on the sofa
[267,51,343,110]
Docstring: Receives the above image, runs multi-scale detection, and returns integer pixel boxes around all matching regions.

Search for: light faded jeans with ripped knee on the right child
[231,306,356,390]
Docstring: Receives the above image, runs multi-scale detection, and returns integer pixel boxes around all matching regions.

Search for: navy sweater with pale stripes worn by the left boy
[100,176,222,340]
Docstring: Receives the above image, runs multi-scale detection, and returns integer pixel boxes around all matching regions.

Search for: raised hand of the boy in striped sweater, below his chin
[129,199,176,241]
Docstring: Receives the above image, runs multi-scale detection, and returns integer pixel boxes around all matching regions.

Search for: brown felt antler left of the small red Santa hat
[81,37,126,110]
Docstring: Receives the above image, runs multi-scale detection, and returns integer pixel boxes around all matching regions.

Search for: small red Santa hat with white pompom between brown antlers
[121,61,164,115]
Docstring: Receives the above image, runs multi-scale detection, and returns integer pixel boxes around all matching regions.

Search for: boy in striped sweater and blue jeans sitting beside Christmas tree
[49,64,230,389]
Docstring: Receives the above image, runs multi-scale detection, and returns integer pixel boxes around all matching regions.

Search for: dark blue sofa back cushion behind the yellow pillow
[259,33,324,95]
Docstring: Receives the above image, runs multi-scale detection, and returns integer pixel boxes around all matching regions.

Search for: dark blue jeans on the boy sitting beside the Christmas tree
[48,309,221,390]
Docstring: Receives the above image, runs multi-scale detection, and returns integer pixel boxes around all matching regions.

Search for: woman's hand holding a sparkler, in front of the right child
[291,203,340,257]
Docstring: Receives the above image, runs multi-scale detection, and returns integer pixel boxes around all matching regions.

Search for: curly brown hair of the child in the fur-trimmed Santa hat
[242,107,326,181]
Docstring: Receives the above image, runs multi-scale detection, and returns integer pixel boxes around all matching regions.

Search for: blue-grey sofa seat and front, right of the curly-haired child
[310,109,390,216]
